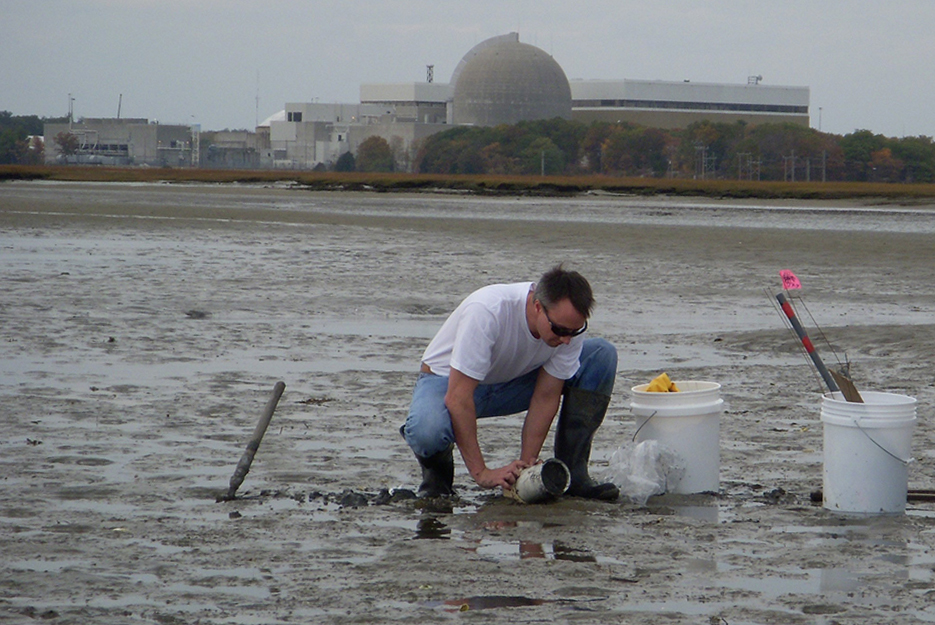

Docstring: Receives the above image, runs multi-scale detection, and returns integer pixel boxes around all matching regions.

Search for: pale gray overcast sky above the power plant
[0,0,935,137]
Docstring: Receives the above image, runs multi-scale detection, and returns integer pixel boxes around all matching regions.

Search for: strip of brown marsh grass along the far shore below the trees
[0,165,935,205]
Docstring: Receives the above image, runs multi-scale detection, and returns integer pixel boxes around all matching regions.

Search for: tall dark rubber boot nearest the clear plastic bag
[555,388,620,501]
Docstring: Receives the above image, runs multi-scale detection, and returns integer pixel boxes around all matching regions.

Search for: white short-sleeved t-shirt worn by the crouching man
[422,282,584,384]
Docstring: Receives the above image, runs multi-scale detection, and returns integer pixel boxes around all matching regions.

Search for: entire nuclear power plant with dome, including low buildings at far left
[46,33,809,169]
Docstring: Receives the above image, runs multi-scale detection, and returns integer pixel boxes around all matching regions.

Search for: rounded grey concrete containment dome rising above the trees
[451,33,571,126]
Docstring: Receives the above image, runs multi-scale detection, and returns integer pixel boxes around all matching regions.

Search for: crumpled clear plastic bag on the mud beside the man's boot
[604,439,685,506]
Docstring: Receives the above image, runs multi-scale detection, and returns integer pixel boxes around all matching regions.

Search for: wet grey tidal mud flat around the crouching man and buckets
[0,183,935,625]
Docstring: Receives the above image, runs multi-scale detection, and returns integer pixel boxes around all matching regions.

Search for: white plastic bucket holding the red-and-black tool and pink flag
[821,391,916,514]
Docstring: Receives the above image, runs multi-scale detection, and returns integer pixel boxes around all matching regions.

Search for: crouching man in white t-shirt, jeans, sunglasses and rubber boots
[400,265,619,500]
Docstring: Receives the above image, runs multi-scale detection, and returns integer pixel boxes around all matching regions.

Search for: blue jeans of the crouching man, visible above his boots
[403,338,617,458]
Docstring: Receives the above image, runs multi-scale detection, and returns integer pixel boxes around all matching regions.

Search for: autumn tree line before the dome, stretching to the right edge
[413,119,935,182]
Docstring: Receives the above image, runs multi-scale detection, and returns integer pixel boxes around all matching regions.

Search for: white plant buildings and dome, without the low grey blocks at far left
[258,33,809,169]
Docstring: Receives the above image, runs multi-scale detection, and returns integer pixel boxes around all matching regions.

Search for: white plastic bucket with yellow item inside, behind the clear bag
[630,380,724,495]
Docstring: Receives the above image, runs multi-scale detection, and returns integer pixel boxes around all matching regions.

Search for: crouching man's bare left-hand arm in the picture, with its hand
[445,368,528,488]
